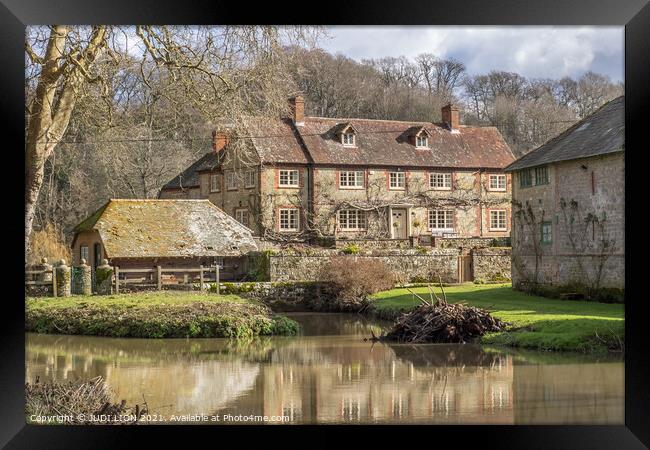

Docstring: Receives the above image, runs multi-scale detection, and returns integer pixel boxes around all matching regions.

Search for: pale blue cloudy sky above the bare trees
[318,26,624,81]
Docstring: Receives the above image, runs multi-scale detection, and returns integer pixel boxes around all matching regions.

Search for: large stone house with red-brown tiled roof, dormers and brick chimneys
[160,97,514,243]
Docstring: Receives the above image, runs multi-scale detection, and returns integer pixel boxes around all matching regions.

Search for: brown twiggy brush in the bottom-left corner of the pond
[25,377,149,425]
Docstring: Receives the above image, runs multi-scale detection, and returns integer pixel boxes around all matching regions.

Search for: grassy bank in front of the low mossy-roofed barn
[25,291,298,338]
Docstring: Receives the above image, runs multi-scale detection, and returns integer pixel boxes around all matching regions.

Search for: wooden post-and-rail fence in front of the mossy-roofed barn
[113,265,221,294]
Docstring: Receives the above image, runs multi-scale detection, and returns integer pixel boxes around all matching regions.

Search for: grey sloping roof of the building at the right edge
[506,96,625,171]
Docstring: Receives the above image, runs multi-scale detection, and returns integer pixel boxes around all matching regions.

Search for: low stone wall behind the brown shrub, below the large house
[269,249,458,283]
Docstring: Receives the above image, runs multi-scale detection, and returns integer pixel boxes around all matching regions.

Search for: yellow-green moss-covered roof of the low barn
[75,199,257,258]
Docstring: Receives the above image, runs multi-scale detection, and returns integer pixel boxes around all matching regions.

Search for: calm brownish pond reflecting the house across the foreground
[26,313,624,424]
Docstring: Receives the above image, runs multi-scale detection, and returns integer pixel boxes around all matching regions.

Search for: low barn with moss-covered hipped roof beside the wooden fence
[72,199,257,280]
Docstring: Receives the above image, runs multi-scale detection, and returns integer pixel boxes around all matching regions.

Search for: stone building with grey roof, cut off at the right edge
[506,96,625,289]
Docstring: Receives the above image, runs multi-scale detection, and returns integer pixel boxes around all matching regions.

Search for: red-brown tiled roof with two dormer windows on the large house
[298,117,514,168]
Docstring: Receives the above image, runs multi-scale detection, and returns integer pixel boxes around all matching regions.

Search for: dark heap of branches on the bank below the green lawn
[375,282,509,344]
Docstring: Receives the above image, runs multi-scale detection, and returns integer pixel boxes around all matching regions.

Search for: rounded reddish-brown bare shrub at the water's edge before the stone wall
[320,256,395,311]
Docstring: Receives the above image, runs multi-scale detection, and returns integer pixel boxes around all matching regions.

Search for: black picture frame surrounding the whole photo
[0,0,650,449]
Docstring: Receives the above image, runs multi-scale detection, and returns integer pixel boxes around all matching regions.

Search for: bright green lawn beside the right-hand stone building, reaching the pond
[373,284,625,352]
